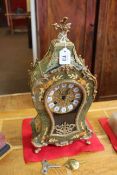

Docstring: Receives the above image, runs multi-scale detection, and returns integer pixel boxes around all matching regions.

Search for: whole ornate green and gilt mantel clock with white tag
[31,17,97,151]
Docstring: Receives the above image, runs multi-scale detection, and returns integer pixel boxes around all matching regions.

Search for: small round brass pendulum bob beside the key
[65,159,80,170]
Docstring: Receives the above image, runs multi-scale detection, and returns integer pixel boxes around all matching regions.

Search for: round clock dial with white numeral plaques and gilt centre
[46,82,82,114]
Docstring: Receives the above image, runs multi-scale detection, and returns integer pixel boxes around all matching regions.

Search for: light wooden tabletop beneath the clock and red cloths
[0,93,117,175]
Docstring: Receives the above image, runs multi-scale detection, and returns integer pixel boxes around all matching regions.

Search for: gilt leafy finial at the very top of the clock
[53,17,71,33]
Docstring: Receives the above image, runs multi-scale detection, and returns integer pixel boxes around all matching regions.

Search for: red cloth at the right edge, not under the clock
[99,117,117,151]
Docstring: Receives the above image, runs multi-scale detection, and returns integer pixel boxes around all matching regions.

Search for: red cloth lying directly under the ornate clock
[22,119,104,163]
